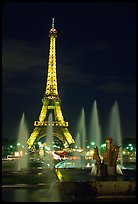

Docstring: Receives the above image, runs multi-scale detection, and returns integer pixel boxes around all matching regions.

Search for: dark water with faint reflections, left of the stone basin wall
[2,169,59,202]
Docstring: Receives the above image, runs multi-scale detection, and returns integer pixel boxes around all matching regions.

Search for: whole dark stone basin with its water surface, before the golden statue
[57,169,136,200]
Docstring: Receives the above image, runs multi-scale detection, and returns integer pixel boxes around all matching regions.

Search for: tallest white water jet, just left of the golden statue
[89,100,102,150]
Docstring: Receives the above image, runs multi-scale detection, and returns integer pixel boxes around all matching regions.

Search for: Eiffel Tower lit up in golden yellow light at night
[27,18,75,149]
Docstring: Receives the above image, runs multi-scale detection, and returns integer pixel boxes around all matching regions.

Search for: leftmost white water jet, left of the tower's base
[17,113,29,171]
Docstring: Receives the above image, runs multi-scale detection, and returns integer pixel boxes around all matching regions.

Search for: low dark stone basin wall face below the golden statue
[60,181,136,201]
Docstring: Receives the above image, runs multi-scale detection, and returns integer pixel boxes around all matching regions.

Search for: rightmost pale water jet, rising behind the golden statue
[109,101,123,165]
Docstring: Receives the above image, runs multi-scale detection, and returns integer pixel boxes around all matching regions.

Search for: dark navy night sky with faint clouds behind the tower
[2,2,136,142]
